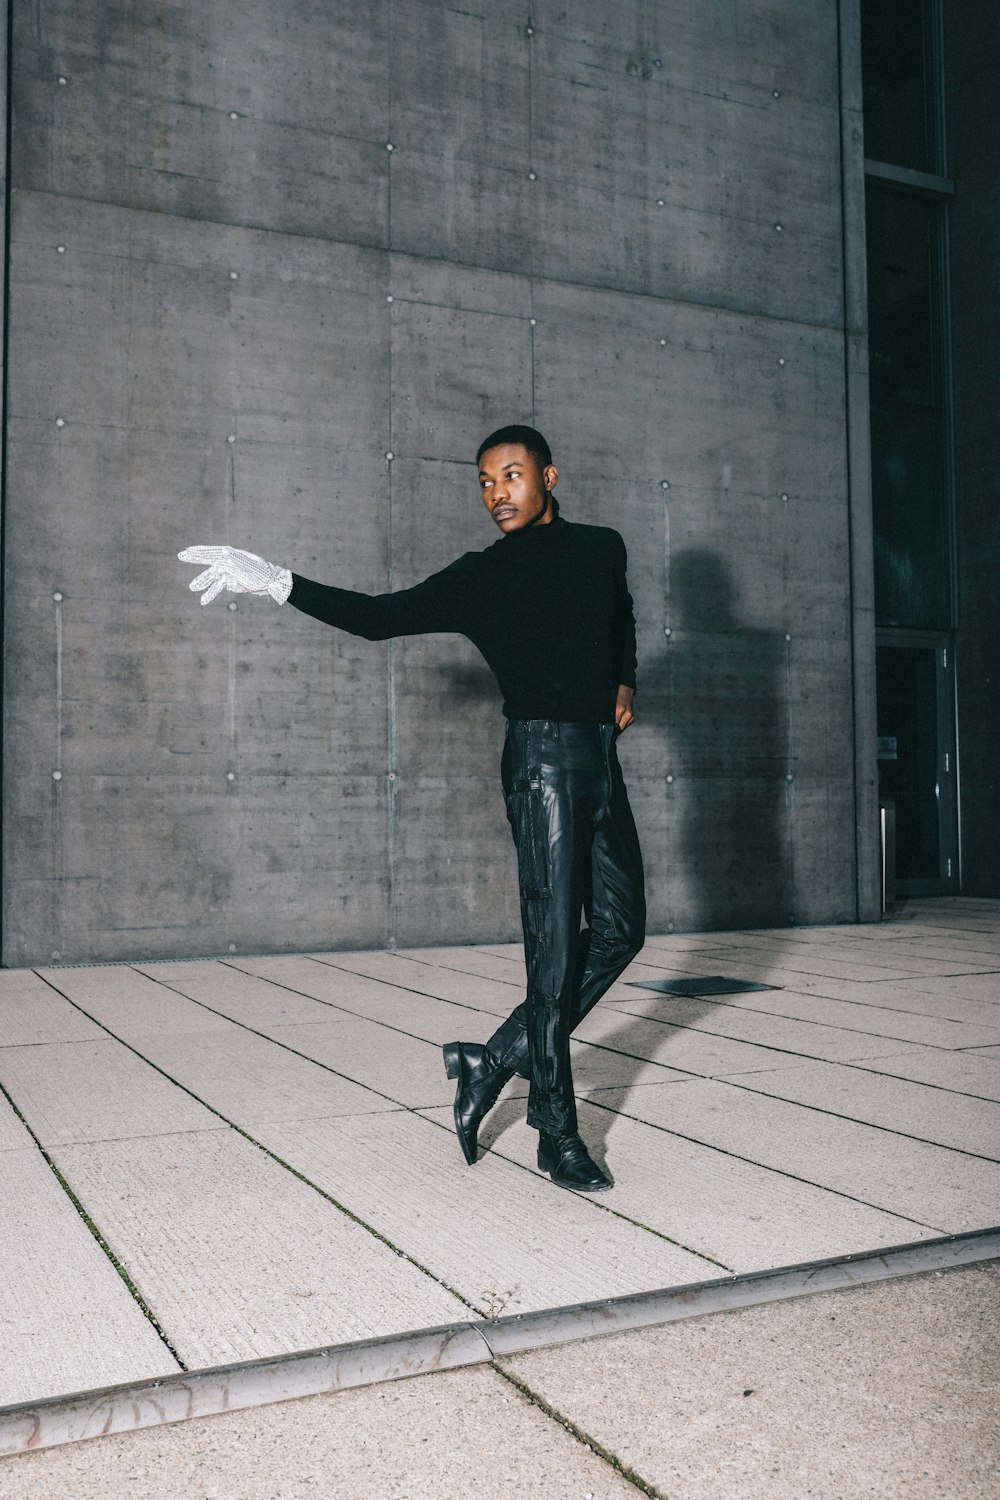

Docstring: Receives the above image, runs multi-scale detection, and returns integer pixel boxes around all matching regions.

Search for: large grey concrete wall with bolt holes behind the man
[3,0,876,963]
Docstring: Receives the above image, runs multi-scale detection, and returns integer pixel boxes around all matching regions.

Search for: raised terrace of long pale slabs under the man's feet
[0,900,1000,1496]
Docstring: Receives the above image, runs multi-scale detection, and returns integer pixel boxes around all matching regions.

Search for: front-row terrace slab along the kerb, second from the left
[55,1130,463,1368]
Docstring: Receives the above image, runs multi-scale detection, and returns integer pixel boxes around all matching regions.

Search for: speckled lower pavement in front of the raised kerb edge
[0,1263,1000,1500]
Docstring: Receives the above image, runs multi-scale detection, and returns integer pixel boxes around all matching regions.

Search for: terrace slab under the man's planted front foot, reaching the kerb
[433,1097,937,1286]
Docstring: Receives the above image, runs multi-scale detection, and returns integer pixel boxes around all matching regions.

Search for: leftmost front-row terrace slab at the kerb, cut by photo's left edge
[0,1133,180,1406]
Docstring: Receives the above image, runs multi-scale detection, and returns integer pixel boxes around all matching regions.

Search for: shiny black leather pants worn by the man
[486,719,646,1136]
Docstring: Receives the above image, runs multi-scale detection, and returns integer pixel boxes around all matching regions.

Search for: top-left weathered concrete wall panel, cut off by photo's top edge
[13,0,388,245]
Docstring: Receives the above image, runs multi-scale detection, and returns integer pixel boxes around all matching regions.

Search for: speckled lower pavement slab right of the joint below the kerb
[502,1266,1000,1500]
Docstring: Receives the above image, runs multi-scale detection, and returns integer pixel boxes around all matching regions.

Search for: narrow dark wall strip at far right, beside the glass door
[945,0,1000,896]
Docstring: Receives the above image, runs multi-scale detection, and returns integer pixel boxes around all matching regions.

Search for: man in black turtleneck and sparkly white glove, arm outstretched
[180,425,646,1193]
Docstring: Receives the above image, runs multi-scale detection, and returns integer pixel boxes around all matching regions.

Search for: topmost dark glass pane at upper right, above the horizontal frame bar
[861,0,943,173]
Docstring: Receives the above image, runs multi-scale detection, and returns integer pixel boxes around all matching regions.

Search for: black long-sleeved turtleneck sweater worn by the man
[288,516,636,723]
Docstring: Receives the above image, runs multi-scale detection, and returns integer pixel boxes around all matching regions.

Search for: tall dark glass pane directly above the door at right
[867,182,951,630]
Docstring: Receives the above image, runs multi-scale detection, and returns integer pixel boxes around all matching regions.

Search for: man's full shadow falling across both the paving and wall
[481,548,795,1167]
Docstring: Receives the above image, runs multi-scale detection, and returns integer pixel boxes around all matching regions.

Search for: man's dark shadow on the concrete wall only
[643,548,795,932]
